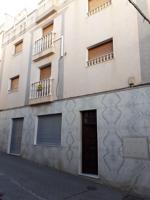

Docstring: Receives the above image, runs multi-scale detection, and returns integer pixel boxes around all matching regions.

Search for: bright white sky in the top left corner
[0,0,40,24]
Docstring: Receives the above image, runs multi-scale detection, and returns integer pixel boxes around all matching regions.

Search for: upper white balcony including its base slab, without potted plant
[33,32,55,62]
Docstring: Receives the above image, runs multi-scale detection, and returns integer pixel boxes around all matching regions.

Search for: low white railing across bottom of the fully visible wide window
[87,52,114,67]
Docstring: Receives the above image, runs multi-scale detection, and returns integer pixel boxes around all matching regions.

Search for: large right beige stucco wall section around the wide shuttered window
[64,0,141,97]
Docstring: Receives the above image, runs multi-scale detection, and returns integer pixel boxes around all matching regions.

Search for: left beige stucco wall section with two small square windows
[0,32,31,109]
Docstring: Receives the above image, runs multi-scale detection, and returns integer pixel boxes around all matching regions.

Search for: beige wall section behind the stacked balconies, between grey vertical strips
[30,15,62,100]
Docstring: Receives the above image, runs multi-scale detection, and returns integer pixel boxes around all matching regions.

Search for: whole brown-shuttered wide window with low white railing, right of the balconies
[87,39,113,66]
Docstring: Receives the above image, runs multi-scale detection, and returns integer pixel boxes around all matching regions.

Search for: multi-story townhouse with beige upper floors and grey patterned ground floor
[0,0,150,195]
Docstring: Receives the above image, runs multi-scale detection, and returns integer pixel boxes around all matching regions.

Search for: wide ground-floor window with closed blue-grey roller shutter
[37,114,62,145]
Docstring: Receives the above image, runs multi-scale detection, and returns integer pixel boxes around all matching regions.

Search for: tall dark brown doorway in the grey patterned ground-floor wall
[82,110,98,175]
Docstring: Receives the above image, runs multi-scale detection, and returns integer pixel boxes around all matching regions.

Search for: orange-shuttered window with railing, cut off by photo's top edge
[88,0,111,15]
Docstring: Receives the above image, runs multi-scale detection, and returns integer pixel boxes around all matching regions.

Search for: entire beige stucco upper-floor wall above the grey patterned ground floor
[0,0,146,109]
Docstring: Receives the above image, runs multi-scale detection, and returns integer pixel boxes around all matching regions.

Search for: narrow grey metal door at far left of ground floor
[10,118,23,155]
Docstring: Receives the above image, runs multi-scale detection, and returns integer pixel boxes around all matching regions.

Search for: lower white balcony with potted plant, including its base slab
[29,78,53,105]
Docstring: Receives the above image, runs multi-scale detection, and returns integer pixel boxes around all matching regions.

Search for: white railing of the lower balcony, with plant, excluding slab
[30,78,53,99]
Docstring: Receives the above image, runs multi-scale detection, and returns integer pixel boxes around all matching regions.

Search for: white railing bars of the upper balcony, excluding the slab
[33,32,55,55]
